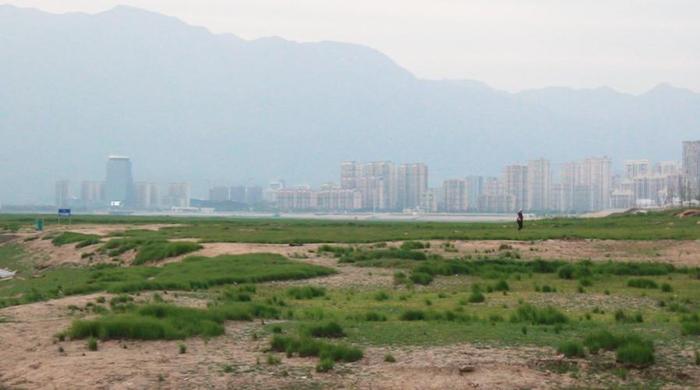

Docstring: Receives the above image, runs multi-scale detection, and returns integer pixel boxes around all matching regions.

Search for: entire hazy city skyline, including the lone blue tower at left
[45,141,700,214]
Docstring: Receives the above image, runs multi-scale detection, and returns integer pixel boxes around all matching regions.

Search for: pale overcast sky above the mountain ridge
[5,0,700,93]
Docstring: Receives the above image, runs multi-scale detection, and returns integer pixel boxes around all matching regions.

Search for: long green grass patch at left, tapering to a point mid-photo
[0,254,335,307]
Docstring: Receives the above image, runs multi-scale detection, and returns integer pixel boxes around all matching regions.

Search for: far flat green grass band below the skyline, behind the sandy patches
[0,210,700,243]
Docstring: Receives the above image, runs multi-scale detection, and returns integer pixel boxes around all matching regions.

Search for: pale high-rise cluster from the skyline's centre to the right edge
[256,141,700,214]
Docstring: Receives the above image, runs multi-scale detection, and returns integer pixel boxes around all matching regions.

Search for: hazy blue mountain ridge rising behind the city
[0,5,700,203]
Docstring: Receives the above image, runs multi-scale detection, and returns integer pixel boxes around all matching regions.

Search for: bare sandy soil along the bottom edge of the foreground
[0,294,580,389]
